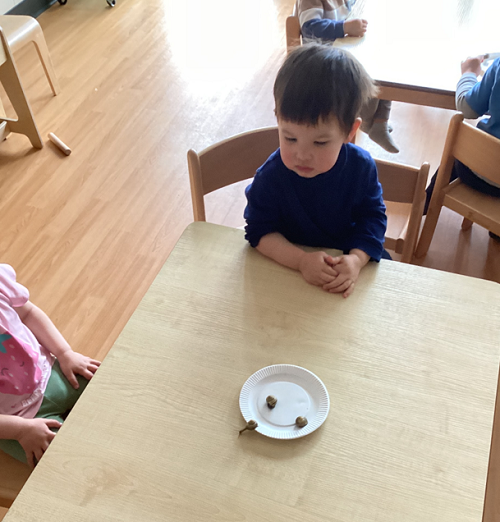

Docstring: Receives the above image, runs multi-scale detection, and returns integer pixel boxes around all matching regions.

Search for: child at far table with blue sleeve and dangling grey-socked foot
[297,0,399,154]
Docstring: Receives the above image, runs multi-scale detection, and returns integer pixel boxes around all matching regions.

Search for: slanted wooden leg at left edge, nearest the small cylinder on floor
[0,54,43,149]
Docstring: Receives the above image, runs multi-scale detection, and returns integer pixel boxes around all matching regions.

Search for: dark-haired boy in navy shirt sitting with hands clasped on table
[245,44,389,297]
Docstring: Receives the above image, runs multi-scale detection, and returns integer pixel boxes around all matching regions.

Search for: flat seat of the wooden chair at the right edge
[444,180,500,235]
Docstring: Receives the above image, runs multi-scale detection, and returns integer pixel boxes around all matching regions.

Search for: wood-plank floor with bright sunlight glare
[0,0,500,358]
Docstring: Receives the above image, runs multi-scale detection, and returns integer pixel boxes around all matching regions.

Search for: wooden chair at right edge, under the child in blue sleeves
[416,114,500,257]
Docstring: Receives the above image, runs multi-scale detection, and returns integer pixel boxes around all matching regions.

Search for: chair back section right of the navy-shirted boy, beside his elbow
[375,155,429,263]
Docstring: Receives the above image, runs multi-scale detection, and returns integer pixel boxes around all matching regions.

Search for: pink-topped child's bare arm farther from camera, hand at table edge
[15,301,101,389]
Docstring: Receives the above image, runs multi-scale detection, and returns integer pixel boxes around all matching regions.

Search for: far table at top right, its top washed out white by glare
[334,0,500,109]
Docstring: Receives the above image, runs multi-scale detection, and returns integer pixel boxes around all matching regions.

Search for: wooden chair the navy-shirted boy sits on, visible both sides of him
[188,127,429,263]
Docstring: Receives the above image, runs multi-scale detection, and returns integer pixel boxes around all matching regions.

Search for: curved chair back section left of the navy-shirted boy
[188,127,279,221]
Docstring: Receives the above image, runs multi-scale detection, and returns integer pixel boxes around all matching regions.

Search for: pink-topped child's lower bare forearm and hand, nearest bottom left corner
[0,415,61,468]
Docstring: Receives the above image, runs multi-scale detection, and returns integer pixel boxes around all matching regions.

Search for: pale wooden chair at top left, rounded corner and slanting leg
[0,15,60,96]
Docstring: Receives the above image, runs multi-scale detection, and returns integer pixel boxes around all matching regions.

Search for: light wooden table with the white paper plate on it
[6,223,500,522]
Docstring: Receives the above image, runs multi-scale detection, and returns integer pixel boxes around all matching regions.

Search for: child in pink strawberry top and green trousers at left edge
[0,264,101,468]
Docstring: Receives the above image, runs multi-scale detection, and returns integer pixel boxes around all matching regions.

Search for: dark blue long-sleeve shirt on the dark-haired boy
[244,143,387,261]
